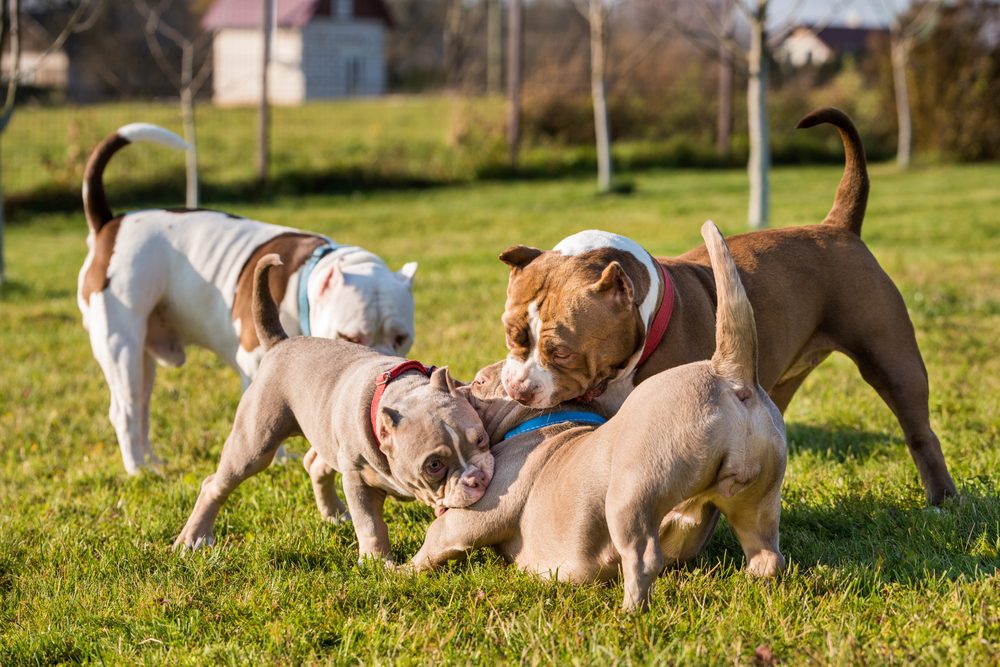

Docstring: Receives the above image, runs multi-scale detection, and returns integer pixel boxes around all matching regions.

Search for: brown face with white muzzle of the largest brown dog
[500,246,645,409]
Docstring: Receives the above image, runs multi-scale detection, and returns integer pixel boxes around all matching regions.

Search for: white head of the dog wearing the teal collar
[309,250,417,356]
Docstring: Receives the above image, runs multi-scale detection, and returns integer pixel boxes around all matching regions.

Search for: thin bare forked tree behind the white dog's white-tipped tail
[133,0,211,208]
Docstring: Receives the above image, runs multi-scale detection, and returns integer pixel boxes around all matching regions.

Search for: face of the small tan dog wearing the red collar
[378,368,493,516]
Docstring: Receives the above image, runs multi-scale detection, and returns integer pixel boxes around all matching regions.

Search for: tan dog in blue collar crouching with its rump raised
[412,222,785,610]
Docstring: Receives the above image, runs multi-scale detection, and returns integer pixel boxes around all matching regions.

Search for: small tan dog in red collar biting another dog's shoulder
[174,255,493,561]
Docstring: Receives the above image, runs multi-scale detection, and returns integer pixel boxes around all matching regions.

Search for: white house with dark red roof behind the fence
[203,0,392,105]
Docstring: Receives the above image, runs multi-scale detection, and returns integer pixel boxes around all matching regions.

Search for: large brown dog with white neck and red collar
[500,108,955,505]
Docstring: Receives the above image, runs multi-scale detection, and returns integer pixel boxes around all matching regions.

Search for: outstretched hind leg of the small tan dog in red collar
[174,387,296,549]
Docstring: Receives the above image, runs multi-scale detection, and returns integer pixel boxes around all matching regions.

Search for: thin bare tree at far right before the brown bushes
[878,0,941,169]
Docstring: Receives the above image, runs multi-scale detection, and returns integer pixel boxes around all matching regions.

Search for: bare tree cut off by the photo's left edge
[0,0,104,284]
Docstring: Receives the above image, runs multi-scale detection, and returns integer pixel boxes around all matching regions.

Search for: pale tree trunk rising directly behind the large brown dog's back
[747,0,771,229]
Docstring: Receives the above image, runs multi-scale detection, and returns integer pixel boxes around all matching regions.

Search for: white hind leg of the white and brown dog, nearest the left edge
[87,290,152,475]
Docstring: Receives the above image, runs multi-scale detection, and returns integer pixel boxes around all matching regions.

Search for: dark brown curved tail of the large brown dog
[795,107,868,236]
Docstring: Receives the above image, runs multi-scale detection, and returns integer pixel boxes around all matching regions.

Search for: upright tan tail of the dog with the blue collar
[701,220,757,391]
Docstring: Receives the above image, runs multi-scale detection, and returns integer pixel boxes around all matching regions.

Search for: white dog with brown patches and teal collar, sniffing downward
[77,123,417,474]
